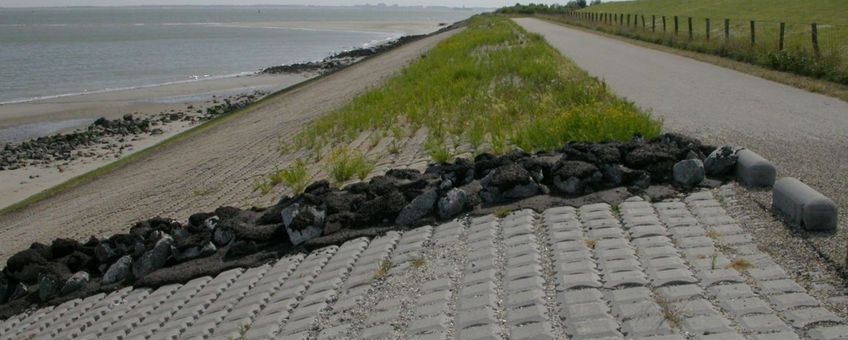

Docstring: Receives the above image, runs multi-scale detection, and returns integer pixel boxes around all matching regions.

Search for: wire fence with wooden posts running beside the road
[547,12,848,84]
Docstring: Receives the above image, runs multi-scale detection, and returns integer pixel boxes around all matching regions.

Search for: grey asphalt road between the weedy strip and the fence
[515,18,848,265]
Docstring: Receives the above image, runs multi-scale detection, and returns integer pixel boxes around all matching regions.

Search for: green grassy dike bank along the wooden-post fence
[582,0,848,84]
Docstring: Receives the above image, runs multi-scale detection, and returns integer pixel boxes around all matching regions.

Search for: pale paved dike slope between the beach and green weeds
[0,30,457,266]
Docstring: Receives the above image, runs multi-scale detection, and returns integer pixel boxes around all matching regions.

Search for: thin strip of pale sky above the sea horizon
[0,0,612,7]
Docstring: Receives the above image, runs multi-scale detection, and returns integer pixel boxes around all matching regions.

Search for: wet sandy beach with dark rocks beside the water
[0,74,313,209]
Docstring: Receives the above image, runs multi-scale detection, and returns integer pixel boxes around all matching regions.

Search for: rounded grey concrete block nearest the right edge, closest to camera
[772,177,837,231]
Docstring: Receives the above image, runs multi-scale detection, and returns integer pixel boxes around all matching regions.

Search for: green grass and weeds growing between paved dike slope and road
[294,16,661,161]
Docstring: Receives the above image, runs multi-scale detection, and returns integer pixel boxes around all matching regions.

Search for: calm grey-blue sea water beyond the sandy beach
[0,6,479,103]
